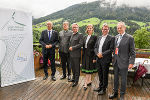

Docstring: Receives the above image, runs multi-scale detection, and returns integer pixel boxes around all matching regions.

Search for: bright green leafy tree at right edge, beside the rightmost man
[133,28,150,49]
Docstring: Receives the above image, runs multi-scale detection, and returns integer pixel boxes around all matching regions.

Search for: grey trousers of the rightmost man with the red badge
[114,62,128,95]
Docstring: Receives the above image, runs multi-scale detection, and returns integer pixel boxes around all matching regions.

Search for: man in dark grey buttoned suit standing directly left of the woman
[69,23,83,87]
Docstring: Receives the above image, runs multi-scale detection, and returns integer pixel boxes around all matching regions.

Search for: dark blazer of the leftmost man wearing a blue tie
[39,30,58,54]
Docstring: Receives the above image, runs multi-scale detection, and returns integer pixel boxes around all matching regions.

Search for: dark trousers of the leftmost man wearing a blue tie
[43,51,56,76]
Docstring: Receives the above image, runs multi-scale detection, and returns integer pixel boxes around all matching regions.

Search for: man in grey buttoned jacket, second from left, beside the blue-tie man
[59,21,72,80]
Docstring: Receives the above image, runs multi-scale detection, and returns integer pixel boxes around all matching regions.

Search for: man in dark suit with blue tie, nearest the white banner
[39,21,58,81]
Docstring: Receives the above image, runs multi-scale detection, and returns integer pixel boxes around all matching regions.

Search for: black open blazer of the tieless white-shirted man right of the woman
[94,35,114,64]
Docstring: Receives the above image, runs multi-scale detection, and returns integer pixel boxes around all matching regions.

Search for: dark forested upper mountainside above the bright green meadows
[33,1,150,25]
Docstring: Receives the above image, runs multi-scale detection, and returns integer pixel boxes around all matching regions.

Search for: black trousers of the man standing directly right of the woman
[96,60,109,90]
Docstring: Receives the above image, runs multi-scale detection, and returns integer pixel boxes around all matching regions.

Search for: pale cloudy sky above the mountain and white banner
[0,0,150,18]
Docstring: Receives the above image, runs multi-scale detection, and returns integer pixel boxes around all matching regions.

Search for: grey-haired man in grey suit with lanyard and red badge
[109,22,135,100]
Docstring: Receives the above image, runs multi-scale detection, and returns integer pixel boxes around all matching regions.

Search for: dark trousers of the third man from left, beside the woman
[70,57,80,83]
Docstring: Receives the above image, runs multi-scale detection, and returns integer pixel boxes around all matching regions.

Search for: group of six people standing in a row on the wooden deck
[39,21,135,100]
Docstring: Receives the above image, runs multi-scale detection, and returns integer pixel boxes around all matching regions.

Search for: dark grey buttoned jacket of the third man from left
[69,33,83,57]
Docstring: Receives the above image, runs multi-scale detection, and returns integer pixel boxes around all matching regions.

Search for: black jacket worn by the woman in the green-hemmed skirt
[83,35,97,59]
